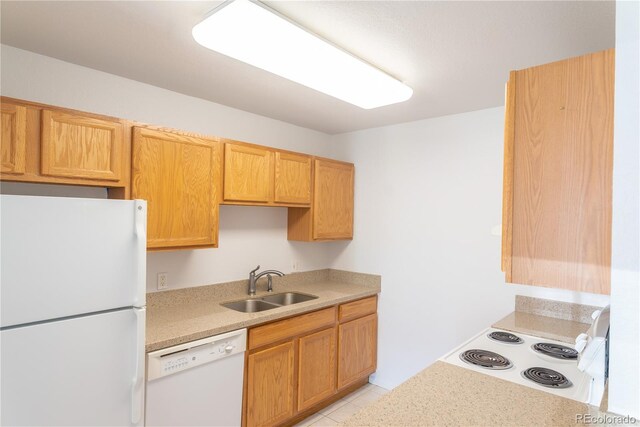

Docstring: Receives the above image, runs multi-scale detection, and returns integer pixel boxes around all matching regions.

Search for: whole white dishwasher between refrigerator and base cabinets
[145,329,247,427]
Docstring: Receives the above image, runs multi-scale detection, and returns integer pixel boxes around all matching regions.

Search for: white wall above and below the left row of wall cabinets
[1,45,344,290]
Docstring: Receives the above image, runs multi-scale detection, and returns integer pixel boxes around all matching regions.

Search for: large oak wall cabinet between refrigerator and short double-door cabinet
[132,128,220,248]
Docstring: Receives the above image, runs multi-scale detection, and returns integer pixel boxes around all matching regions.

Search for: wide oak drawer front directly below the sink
[249,307,336,350]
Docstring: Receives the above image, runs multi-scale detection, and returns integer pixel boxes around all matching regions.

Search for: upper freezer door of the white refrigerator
[0,195,147,327]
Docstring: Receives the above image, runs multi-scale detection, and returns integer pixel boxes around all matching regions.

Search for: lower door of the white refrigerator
[0,309,145,426]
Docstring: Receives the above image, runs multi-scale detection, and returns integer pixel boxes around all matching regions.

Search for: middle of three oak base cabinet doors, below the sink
[298,328,336,411]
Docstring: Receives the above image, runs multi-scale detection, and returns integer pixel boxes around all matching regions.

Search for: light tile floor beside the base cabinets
[294,384,388,427]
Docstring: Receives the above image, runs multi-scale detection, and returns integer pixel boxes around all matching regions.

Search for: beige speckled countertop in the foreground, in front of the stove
[344,361,590,426]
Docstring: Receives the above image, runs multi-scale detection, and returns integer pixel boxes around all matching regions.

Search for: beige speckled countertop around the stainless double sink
[146,274,380,352]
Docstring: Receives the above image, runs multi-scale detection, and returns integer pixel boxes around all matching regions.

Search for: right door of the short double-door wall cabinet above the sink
[275,152,311,204]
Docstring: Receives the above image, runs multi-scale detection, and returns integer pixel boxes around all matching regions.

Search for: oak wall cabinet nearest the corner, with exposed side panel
[287,159,355,241]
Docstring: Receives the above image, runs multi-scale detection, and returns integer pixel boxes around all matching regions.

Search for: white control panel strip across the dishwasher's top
[147,329,247,381]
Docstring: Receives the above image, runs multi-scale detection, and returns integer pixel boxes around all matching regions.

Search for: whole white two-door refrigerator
[0,195,147,426]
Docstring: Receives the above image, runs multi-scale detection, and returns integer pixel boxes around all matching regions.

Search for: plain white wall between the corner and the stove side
[334,108,609,387]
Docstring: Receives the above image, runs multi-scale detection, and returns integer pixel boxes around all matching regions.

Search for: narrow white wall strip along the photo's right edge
[609,1,640,418]
